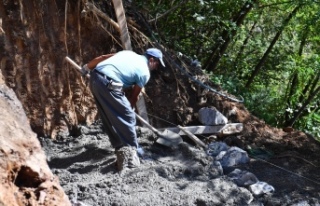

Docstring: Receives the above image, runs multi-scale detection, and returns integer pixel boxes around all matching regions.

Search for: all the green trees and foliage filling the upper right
[135,0,320,142]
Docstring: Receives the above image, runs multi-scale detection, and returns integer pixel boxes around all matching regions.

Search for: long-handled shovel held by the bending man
[65,56,183,147]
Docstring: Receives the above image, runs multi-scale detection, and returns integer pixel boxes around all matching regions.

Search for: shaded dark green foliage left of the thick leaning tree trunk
[137,0,250,60]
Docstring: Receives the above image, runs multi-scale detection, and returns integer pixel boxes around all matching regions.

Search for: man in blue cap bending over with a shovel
[82,48,165,171]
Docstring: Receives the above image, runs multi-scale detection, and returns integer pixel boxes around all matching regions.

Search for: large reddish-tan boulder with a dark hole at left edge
[0,81,71,206]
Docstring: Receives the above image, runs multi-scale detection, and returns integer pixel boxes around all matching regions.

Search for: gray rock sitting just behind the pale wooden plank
[198,107,228,125]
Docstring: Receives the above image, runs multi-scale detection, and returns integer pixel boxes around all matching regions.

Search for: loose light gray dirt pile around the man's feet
[42,125,253,205]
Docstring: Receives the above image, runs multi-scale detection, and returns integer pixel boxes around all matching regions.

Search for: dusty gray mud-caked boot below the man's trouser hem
[116,147,140,171]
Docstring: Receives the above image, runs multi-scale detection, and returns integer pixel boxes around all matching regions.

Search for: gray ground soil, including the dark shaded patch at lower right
[40,120,320,206]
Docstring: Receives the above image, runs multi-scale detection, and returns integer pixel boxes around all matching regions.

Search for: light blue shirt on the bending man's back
[95,50,150,88]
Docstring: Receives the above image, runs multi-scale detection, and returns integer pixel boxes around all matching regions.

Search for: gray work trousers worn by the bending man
[90,70,139,148]
